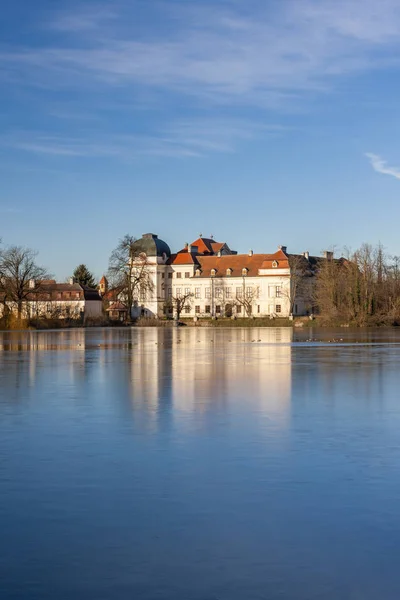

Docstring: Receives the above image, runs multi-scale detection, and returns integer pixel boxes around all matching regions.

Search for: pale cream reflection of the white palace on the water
[131,327,292,426]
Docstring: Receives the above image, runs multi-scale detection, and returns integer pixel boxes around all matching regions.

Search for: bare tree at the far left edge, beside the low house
[0,246,49,319]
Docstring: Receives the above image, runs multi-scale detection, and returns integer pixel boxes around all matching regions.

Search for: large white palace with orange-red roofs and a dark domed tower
[133,233,321,318]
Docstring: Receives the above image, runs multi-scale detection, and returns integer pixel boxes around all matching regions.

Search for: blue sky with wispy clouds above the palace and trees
[0,0,400,280]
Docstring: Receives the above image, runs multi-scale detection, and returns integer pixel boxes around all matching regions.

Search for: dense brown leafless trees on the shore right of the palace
[313,244,400,327]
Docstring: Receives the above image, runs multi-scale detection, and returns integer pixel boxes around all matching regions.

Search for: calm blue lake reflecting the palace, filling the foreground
[0,327,400,600]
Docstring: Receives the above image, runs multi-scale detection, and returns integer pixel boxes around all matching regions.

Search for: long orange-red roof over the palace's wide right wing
[196,250,289,277]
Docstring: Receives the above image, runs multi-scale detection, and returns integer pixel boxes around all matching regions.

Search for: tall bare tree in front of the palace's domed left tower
[108,234,154,320]
